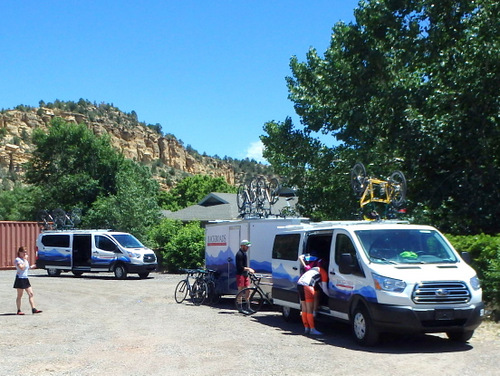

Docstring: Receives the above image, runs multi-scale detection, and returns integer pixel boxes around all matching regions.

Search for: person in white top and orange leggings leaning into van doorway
[297,260,328,336]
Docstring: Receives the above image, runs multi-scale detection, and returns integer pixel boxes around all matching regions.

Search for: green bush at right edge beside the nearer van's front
[447,234,500,311]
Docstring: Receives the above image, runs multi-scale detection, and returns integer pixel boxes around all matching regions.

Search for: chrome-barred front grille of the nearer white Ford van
[412,281,471,304]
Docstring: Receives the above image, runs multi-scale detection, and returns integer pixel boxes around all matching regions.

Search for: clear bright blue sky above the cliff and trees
[0,0,358,160]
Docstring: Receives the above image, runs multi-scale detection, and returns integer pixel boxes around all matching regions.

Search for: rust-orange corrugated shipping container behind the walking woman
[0,221,40,269]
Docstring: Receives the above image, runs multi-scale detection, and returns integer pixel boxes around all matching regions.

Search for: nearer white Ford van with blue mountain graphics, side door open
[272,221,484,345]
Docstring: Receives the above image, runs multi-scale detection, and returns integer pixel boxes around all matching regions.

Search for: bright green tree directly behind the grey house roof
[159,175,236,211]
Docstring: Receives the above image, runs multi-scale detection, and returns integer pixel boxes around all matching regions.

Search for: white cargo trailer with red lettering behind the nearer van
[205,218,308,295]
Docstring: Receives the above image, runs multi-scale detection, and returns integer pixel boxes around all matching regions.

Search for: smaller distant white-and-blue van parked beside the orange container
[36,230,158,279]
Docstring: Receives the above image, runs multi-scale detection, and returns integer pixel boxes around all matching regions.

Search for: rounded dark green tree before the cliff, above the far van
[25,118,124,209]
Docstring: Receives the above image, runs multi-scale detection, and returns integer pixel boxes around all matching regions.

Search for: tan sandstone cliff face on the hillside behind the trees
[0,107,235,189]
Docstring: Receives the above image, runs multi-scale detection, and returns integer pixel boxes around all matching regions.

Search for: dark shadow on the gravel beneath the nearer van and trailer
[209,298,473,354]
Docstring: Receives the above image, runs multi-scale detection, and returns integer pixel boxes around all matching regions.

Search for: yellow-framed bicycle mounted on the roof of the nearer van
[351,162,406,219]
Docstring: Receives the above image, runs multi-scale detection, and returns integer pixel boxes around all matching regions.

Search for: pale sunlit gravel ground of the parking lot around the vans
[0,270,500,376]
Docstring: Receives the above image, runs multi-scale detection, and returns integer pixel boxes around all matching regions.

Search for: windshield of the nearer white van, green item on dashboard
[355,229,458,264]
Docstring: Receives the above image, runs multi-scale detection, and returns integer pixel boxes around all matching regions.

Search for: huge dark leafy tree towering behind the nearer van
[262,0,500,233]
